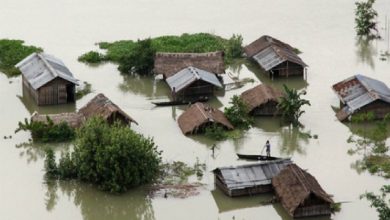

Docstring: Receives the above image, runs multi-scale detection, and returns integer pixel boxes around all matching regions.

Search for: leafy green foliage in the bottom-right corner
[360,185,390,220]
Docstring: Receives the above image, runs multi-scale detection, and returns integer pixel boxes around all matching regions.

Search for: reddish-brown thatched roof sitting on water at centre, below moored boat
[178,102,234,134]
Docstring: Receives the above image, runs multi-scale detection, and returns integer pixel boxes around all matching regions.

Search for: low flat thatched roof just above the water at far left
[31,112,85,128]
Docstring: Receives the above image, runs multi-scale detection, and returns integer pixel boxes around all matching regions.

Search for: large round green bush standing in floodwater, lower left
[45,118,161,193]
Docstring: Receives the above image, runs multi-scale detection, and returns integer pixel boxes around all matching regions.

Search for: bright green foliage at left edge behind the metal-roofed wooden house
[0,39,42,77]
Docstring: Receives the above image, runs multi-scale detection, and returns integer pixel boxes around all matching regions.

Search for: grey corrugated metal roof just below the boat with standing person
[214,159,292,190]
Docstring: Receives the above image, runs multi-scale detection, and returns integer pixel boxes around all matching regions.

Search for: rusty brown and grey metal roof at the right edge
[332,74,390,121]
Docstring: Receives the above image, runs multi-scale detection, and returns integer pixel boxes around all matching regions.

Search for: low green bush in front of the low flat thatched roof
[15,116,75,143]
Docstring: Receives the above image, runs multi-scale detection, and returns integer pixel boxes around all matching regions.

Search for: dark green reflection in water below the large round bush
[44,181,155,220]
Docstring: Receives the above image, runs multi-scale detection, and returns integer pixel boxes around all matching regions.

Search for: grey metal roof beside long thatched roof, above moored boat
[166,66,222,92]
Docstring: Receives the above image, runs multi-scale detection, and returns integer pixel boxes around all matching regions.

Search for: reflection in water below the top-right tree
[355,37,377,69]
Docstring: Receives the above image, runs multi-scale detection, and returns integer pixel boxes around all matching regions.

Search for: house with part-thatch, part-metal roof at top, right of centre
[244,35,307,77]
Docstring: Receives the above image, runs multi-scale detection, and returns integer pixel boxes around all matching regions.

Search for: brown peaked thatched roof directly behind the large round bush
[79,93,138,124]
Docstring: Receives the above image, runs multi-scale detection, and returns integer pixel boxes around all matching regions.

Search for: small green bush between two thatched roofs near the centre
[224,95,254,130]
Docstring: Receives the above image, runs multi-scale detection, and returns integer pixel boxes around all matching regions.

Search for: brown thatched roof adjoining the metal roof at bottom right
[272,164,333,216]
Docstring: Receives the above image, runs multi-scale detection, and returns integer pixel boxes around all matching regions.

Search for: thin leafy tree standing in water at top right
[355,0,378,37]
